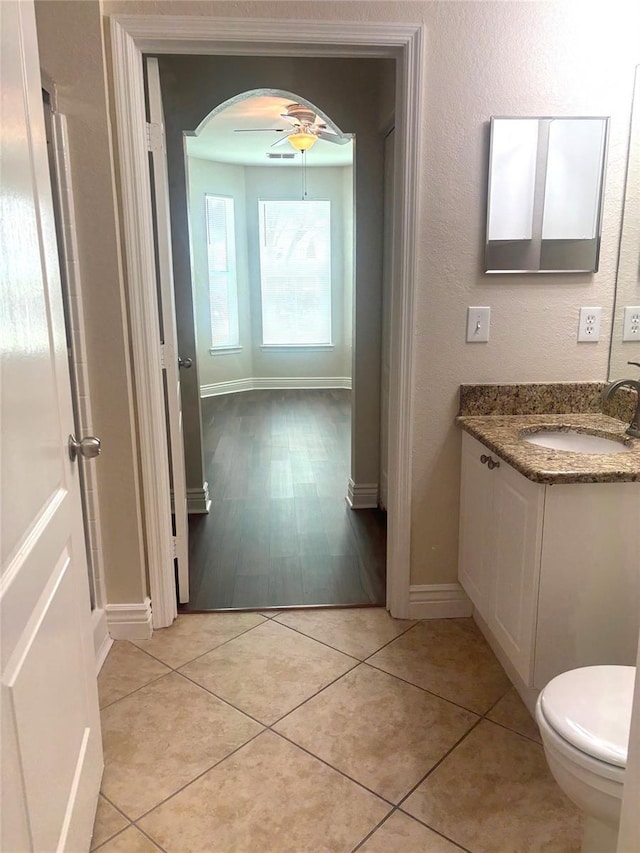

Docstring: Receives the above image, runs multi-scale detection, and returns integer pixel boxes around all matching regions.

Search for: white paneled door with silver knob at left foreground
[0,0,102,853]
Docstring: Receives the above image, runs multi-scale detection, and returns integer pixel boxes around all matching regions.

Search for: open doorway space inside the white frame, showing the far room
[154,68,394,609]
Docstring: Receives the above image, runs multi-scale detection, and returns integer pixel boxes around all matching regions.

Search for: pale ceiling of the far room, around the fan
[185,95,353,168]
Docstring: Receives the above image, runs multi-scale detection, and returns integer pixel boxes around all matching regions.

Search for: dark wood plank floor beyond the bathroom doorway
[181,390,386,611]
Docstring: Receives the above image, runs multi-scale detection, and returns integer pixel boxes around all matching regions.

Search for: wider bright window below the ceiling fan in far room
[259,201,331,346]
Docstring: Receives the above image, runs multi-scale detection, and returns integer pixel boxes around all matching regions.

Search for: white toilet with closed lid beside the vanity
[536,666,636,853]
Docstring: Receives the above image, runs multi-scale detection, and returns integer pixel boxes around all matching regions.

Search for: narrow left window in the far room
[204,195,240,349]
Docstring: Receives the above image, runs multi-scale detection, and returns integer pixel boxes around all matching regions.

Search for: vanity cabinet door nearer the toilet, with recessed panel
[486,462,545,684]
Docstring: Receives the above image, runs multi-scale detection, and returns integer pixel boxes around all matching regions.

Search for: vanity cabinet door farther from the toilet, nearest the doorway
[458,432,496,618]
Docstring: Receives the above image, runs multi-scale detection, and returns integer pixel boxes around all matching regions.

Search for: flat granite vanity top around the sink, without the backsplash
[456,412,640,485]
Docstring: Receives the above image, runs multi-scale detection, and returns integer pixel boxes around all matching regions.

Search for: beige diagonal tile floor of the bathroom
[92,608,581,853]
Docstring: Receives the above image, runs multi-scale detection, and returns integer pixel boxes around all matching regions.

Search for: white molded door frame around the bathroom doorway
[110,15,425,628]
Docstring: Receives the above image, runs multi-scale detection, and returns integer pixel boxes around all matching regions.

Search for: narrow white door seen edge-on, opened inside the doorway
[146,58,191,604]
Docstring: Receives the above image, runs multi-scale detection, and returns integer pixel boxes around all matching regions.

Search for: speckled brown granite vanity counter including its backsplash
[456,382,640,485]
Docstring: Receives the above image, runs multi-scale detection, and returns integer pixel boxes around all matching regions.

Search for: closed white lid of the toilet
[540,666,636,767]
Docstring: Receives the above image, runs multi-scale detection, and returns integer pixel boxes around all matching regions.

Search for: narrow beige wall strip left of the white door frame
[36,0,147,603]
